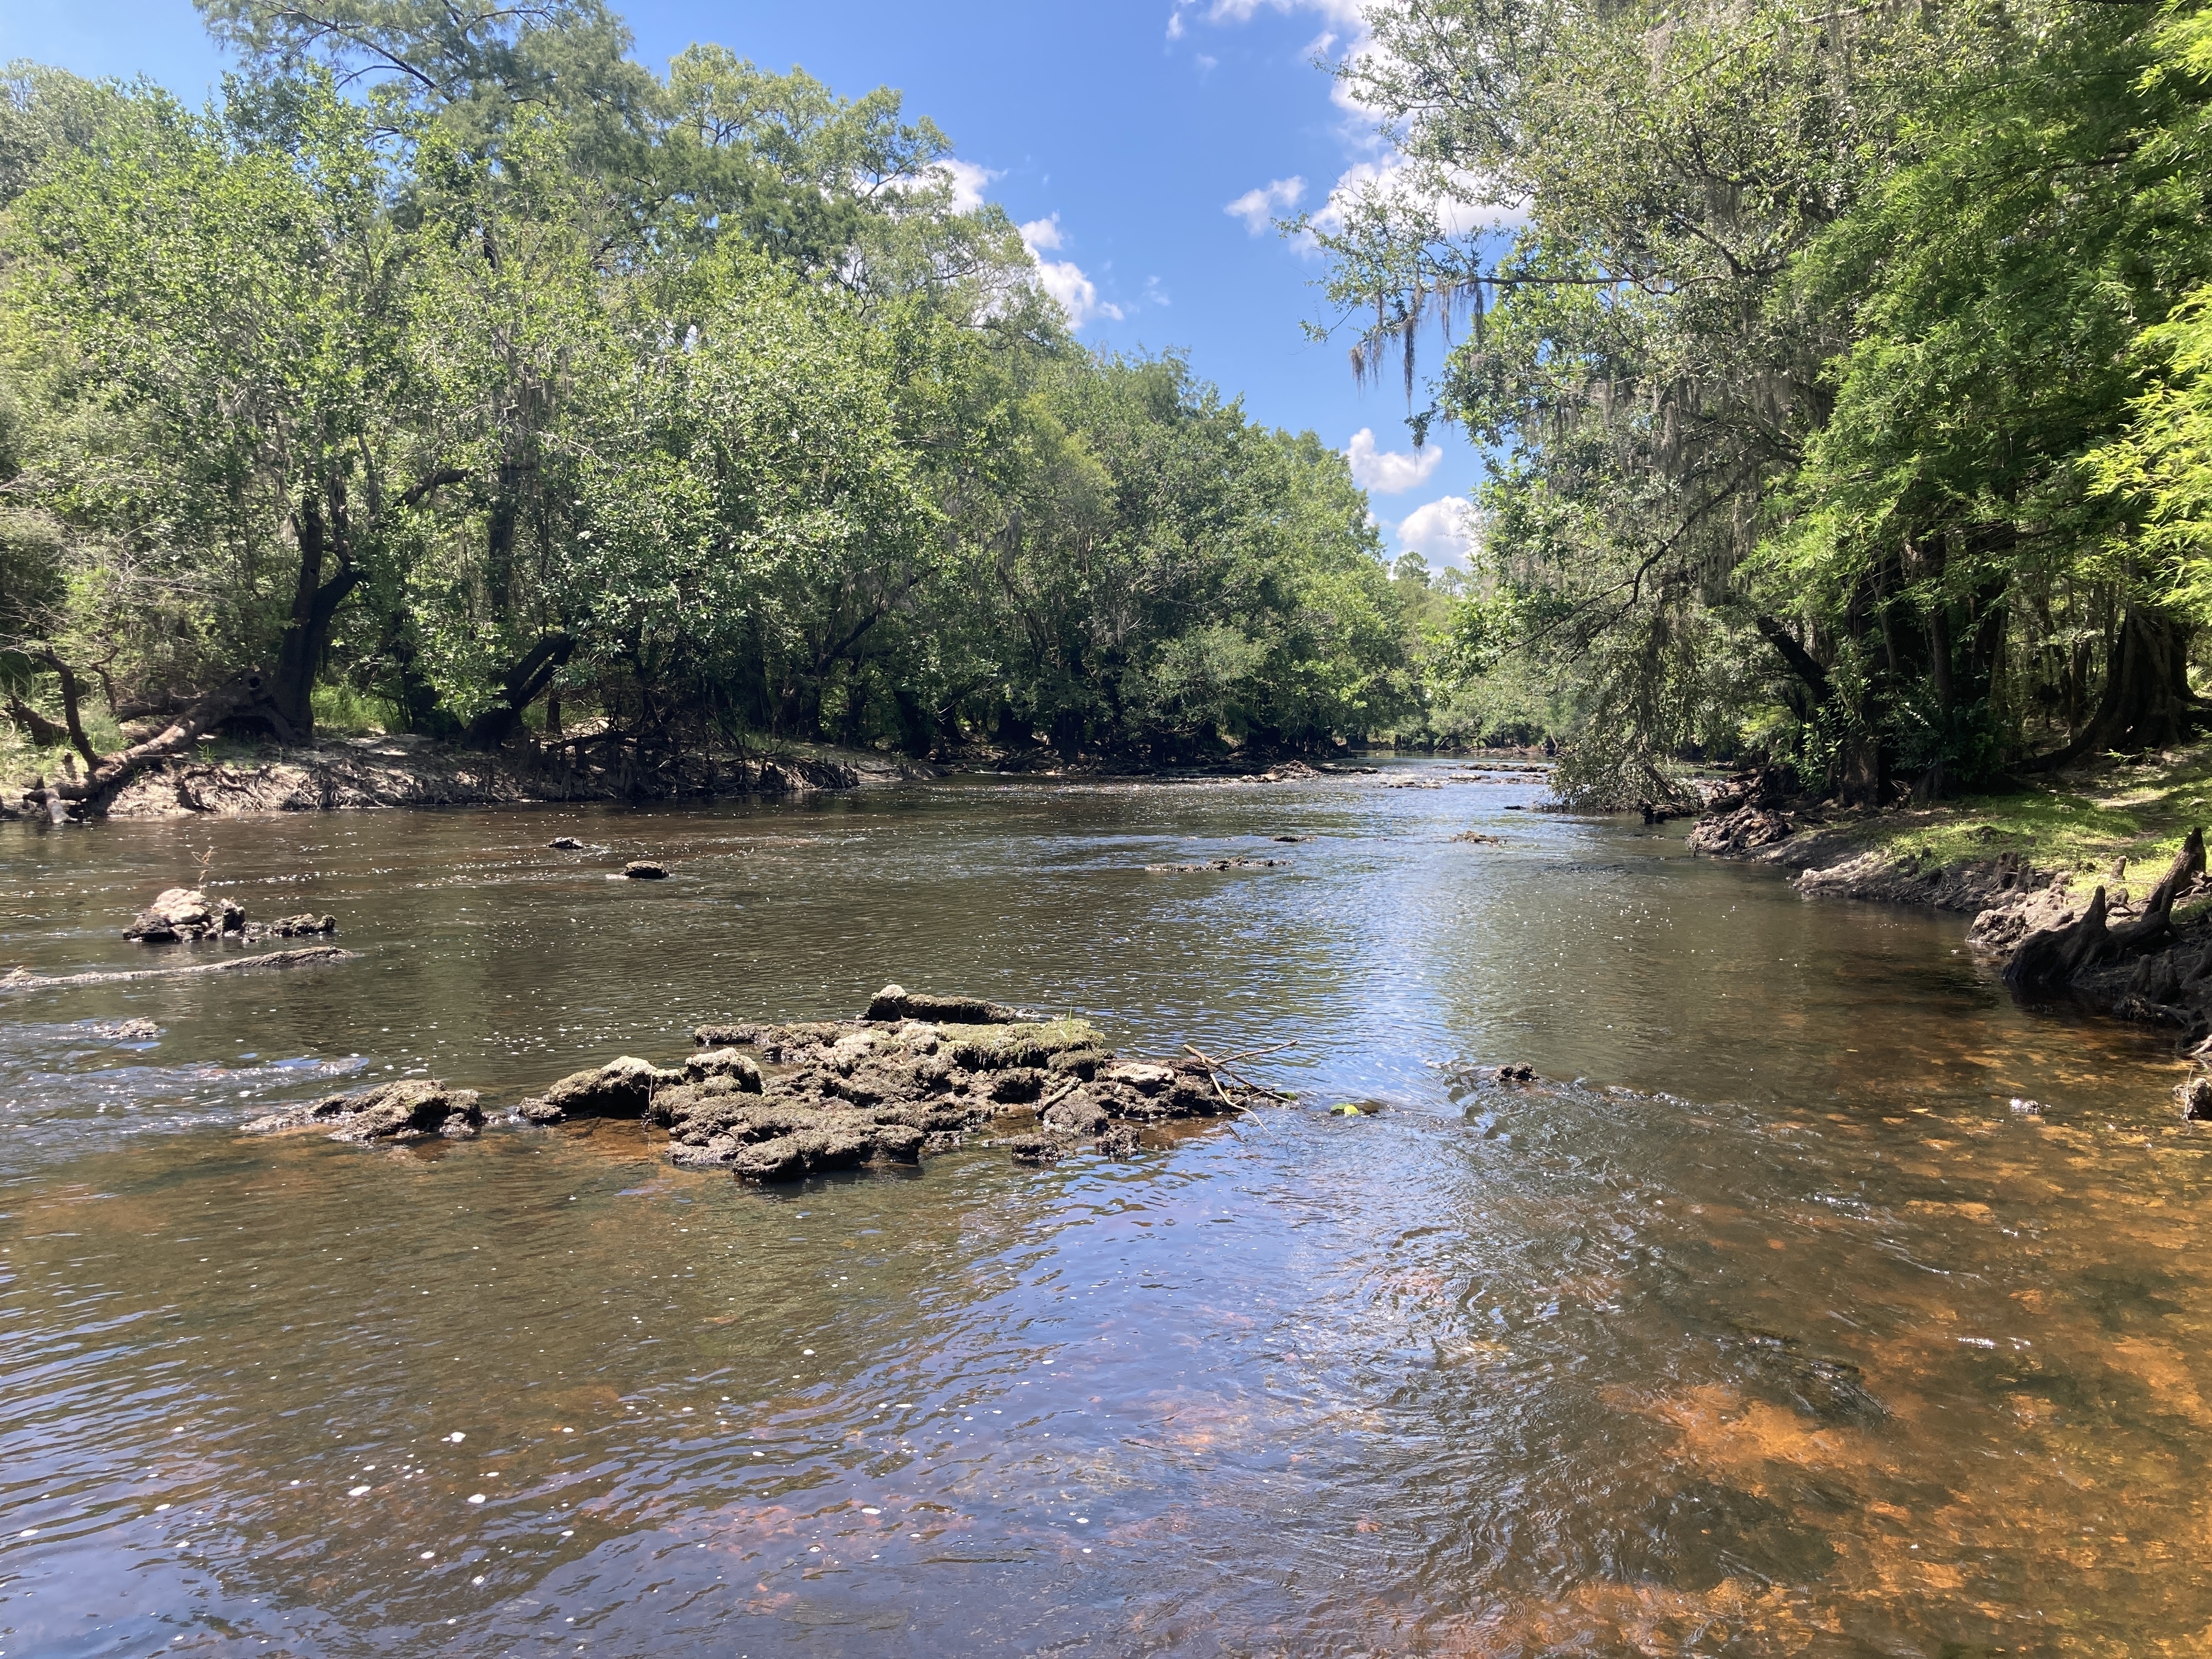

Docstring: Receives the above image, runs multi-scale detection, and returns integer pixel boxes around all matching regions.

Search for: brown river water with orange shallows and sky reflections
[0,765,2212,1659]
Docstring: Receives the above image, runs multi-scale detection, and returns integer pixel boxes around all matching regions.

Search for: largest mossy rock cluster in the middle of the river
[513,984,1239,1181]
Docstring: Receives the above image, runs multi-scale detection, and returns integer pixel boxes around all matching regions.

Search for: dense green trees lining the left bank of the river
[0,0,1458,757]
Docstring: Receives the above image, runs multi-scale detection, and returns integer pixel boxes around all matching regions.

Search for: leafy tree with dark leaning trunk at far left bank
[4,82,456,741]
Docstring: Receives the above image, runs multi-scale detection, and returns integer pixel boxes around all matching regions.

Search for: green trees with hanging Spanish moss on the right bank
[1323,0,2212,799]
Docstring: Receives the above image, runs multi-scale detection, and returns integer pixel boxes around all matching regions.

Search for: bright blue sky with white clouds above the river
[0,0,1480,564]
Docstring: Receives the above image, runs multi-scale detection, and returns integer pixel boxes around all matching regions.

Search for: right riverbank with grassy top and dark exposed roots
[1690,743,2212,1044]
